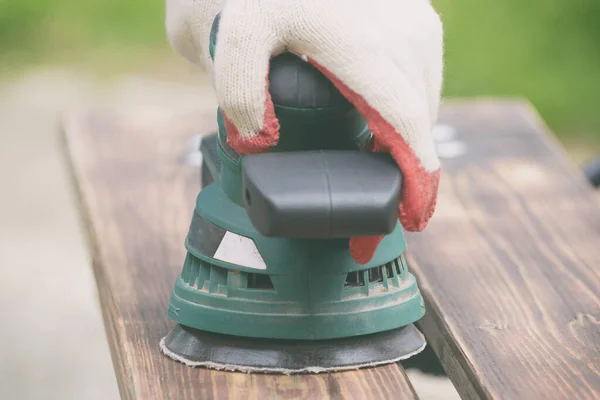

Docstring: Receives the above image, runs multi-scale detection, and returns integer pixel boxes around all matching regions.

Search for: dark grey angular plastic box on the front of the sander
[242,150,402,239]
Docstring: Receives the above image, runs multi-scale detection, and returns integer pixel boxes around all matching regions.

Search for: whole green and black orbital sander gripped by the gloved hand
[160,17,425,374]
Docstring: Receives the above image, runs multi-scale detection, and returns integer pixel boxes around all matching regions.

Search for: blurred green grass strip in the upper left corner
[0,0,166,64]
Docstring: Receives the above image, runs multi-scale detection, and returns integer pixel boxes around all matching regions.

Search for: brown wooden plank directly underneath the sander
[63,111,416,400]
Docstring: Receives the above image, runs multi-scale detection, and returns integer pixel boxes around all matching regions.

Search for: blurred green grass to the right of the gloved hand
[434,0,600,139]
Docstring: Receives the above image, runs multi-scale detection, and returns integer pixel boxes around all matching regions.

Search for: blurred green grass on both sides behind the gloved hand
[0,0,600,152]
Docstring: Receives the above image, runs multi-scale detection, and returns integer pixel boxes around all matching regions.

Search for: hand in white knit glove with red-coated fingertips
[167,0,443,264]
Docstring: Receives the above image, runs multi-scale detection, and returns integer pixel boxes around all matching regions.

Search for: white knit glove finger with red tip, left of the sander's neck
[214,0,282,154]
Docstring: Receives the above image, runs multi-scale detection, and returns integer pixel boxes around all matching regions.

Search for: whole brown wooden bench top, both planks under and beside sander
[63,100,600,399]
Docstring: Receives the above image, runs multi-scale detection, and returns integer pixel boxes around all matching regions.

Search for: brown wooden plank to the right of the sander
[408,100,600,400]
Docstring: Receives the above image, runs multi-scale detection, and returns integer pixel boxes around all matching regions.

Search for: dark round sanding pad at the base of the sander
[160,324,426,375]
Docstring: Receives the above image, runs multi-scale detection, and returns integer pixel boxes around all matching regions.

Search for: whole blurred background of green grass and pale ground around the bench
[0,0,600,400]
